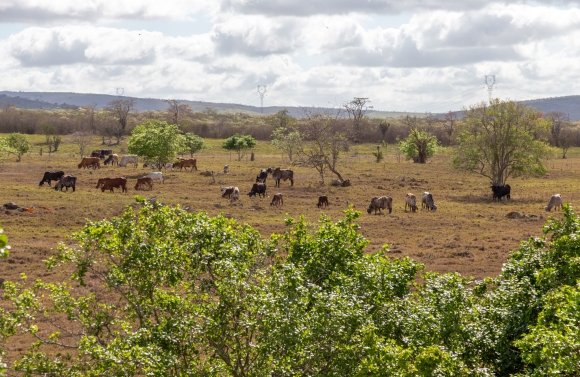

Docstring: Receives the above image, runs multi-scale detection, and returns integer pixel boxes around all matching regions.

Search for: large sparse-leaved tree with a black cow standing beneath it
[452,99,550,186]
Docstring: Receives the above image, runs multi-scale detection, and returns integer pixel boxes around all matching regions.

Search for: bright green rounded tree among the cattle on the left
[127,120,185,168]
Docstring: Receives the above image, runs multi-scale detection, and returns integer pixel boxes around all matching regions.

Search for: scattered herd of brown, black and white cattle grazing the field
[38,149,563,214]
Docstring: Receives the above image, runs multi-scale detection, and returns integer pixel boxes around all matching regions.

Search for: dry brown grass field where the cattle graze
[0,136,580,281]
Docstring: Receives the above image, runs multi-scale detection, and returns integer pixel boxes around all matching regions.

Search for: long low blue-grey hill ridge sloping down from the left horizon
[0,91,425,118]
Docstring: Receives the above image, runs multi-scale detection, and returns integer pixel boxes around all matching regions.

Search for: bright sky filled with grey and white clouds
[0,0,580,112]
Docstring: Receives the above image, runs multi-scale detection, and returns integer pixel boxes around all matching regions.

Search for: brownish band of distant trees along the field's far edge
[0,99,580,146]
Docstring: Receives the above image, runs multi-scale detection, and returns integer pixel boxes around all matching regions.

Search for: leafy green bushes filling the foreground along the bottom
[0,202,580,376]
